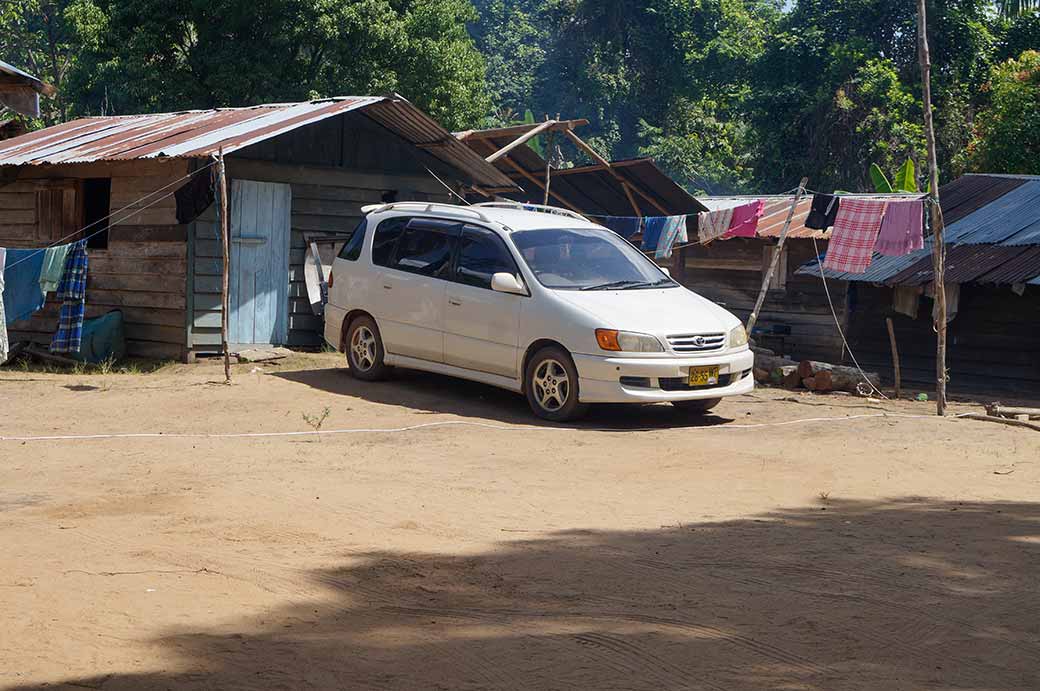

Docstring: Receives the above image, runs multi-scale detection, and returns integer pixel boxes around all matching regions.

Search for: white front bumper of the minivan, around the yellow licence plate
[573,349,755,403]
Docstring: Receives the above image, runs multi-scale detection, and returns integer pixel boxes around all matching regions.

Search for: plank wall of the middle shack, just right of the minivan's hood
[673,238,848,362]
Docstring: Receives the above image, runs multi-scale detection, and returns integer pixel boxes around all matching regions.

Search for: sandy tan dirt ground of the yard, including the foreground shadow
[0,354,1040,691]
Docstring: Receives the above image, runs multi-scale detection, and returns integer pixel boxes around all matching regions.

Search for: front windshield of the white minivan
[511,228,677,290]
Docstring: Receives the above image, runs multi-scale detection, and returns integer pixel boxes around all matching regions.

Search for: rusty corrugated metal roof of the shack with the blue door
[0,96,513,186]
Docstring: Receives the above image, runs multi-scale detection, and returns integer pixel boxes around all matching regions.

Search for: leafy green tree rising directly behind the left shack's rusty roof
[66,0,491,128]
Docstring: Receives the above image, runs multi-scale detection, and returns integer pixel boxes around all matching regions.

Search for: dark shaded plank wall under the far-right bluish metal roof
[849,284,1040,401]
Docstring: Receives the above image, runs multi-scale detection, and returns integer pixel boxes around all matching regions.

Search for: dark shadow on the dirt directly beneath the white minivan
[271,367,732,431]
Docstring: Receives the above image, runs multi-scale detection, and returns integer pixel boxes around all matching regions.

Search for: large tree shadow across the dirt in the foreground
[24,497,1040,691]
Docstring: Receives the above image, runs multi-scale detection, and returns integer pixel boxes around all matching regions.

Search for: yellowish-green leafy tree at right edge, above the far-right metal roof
[957,50,1040,175]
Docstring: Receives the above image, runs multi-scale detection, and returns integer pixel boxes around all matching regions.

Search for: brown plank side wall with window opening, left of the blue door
[0,160,187,358]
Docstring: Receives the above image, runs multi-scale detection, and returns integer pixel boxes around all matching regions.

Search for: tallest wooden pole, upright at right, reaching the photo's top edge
[917,0,946,415]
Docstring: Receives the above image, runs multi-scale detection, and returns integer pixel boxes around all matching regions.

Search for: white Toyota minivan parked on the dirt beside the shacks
[324,202,754,420]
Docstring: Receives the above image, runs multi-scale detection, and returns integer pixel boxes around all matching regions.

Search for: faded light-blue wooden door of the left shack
[228,180,292,343]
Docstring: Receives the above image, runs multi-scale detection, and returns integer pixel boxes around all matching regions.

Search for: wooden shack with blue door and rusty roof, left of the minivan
[0,96,512,360]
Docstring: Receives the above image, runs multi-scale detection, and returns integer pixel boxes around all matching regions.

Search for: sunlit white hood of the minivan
[553,287,740,336]
